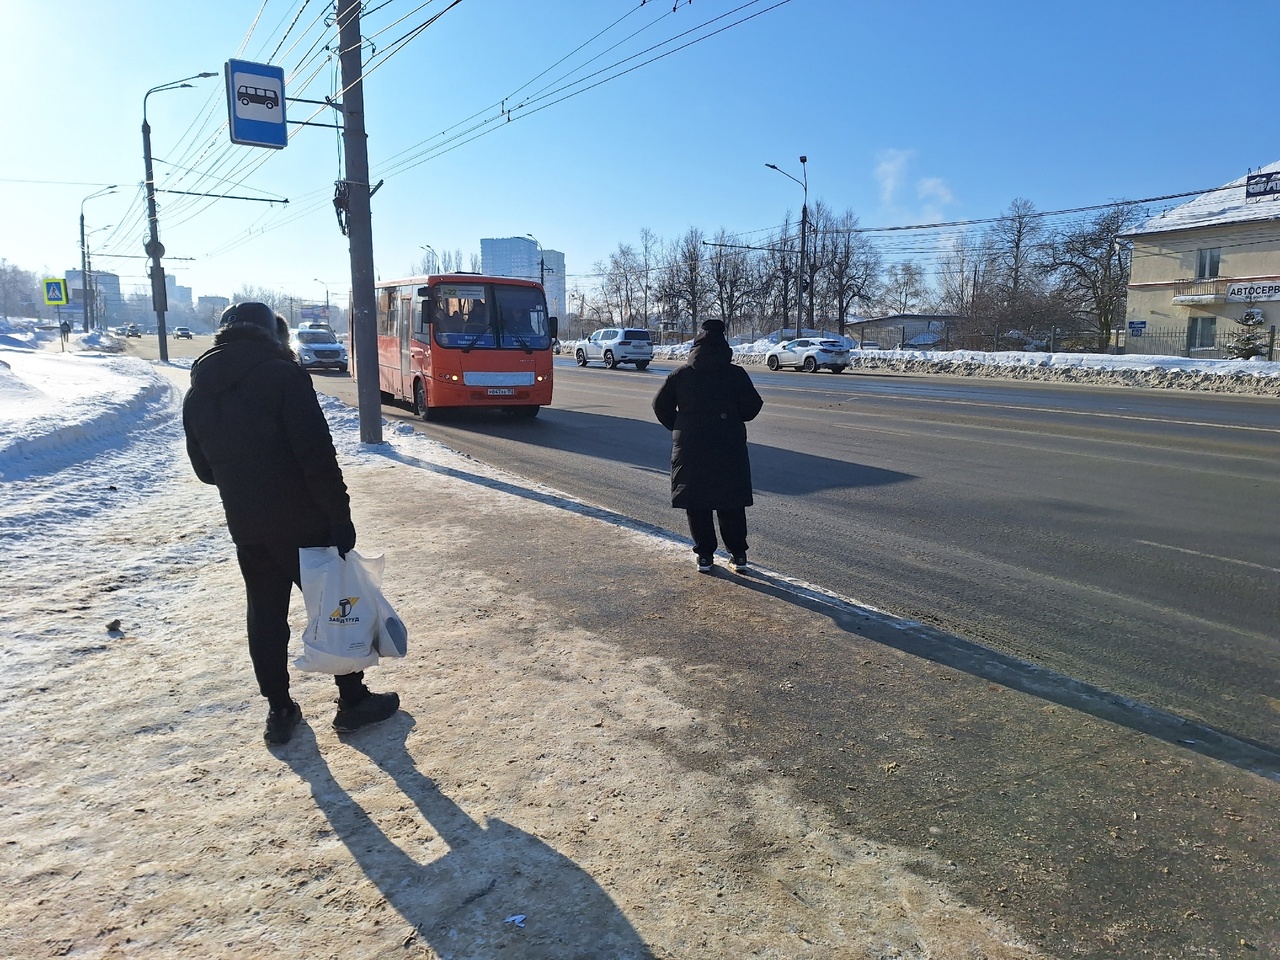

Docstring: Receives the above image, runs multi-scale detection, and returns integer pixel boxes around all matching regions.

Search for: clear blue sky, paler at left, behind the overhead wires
[0,0,1280,300]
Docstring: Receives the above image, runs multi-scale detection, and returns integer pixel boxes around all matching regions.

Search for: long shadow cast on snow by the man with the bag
[282,712,654,960]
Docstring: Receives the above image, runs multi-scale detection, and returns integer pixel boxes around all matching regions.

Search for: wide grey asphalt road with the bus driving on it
[154,338,1280,750]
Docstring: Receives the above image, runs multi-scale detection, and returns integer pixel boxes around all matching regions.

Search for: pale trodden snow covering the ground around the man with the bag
[0,317,1276,960]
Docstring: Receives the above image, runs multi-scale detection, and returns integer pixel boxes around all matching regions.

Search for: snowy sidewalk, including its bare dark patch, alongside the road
[0,351,1280,960]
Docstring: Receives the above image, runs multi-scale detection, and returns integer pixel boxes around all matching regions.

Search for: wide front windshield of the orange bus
[433,283,550,351]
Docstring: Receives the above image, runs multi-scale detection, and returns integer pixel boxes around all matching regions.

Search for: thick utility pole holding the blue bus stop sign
[337,0,383,443]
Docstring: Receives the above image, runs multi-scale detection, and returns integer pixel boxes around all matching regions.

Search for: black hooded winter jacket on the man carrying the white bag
[182,326,351,547]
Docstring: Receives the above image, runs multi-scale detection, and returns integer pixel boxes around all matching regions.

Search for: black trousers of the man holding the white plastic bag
[236,543,365,708]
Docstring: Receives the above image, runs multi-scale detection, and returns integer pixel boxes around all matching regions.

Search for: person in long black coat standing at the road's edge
[653,320,764,573]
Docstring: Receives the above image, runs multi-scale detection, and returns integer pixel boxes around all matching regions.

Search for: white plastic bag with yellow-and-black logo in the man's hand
[293,547,385,675]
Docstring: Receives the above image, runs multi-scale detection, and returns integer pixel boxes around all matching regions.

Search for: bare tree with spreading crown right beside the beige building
[1047,204,1142,352]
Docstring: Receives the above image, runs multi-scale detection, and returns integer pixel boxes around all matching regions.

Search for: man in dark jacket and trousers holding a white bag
[182,302,399,744]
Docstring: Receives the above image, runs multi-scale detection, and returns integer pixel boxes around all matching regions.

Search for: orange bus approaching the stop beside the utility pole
[351,274,557,420]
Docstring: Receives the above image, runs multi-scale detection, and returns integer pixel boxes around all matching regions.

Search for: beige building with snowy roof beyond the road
[1125,161,1280,357]
